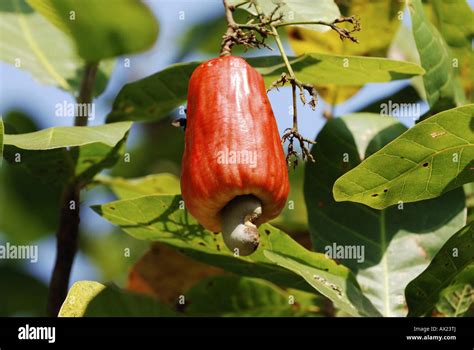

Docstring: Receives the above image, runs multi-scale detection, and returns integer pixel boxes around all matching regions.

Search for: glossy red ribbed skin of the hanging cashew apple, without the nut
[181,56,290,232]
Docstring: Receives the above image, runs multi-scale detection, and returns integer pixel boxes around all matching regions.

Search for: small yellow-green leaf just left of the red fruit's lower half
[94,173,181,199]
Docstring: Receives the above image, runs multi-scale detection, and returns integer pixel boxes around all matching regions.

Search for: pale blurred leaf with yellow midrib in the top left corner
[0,0,113,95]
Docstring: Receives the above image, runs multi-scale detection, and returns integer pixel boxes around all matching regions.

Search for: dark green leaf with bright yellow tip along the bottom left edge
[58,281,176,317]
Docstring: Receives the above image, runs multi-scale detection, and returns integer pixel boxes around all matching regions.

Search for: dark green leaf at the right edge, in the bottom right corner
[405,224,474,317]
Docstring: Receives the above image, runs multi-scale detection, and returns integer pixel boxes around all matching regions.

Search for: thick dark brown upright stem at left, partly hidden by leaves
[47,63,97,317]
